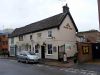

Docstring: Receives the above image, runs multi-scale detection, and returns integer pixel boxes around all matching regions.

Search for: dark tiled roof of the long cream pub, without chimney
[10,13,78,37]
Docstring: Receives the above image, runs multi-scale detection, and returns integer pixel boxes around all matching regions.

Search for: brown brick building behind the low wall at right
[77,30,100,43]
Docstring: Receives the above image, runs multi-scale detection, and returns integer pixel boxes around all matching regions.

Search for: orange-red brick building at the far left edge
[0,33,8,53]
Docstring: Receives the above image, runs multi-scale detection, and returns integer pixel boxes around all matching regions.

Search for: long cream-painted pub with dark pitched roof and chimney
[9,5,78,60]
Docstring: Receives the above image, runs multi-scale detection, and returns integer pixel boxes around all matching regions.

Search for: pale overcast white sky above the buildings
[0,0,99,31]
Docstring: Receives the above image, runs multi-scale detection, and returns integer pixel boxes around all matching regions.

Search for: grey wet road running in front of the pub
[0,59,100,75]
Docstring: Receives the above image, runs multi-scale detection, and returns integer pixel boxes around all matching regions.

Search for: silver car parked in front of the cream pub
[17,51,40,63]
